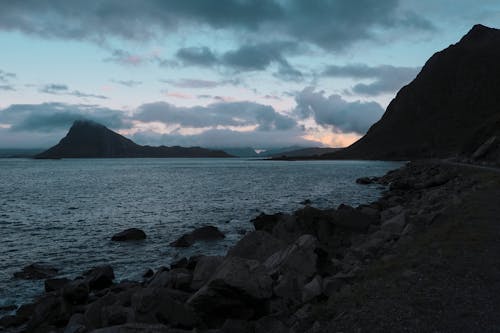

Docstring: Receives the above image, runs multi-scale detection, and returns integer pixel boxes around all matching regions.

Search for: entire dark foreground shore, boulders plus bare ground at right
[0,161,500,332]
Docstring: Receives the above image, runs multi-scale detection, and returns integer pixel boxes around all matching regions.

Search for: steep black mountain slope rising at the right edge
[323,25,500,160]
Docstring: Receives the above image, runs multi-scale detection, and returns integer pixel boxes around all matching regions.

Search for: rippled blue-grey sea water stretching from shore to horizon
[0,159,401,308]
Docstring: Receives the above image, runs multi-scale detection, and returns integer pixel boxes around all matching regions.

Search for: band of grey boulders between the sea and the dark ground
[0,162,488,333]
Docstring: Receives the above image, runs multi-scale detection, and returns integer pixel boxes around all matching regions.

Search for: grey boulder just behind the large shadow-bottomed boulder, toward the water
[227,230,286,262]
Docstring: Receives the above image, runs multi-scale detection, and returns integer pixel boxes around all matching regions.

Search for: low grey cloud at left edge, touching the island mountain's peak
[0,103,131,132]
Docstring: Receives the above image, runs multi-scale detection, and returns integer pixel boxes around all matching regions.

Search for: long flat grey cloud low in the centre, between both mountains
[133,102,297,131]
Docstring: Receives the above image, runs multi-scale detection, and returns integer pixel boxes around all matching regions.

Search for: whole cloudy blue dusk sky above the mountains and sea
[0,0,500,149]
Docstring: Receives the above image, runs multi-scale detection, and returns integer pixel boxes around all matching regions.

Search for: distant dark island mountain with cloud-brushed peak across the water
[35,120,231,159]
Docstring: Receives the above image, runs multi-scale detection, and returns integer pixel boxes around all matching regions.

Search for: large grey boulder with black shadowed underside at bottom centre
[188,257,273,319]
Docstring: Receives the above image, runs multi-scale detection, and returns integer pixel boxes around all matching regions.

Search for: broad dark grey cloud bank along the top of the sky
[0,0,433,50]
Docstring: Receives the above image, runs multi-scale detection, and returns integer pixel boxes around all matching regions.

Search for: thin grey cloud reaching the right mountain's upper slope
[323,64,420,96]
